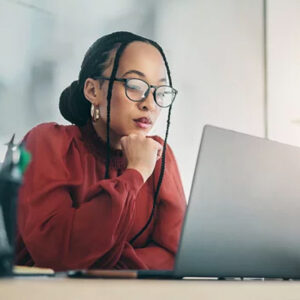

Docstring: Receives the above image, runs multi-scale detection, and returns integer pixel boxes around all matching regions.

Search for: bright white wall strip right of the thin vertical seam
[267,0,300,146]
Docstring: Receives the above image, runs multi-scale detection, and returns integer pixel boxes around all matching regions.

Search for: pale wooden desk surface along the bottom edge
[0,277,300,300]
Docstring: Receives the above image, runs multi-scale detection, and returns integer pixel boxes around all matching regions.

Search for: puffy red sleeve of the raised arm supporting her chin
[18,123,143,271]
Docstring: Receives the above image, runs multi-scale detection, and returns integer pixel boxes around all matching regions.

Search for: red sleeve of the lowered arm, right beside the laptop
[119,137,186,270]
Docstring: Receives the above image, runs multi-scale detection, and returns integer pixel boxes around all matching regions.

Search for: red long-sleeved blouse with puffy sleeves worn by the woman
[16,122,186,271]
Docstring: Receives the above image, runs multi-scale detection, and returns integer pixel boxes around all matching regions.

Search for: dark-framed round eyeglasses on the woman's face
[95,76,178,108]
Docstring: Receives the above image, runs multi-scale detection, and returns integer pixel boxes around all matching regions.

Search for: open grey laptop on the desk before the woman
[69,125,300,279]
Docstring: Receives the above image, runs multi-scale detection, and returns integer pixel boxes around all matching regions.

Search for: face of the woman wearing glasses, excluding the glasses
[94,42,167,148]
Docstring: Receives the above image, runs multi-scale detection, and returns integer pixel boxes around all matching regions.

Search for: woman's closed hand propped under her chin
[121,134,162,182]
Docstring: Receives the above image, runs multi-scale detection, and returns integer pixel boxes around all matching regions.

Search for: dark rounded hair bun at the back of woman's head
[59,80,91,126]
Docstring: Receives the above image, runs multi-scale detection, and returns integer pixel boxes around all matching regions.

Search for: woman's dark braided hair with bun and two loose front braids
[59,31,172,243]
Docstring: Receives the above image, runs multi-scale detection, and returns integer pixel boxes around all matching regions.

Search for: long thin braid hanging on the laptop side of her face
[130,45,172,244]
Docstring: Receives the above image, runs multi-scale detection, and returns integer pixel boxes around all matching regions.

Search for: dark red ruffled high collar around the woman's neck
[79,120,127,169]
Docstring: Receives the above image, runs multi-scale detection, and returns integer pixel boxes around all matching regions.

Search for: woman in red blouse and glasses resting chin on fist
[16,32,186,271]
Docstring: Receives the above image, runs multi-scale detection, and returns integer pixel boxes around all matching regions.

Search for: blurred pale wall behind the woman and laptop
[0,0,300,197]
